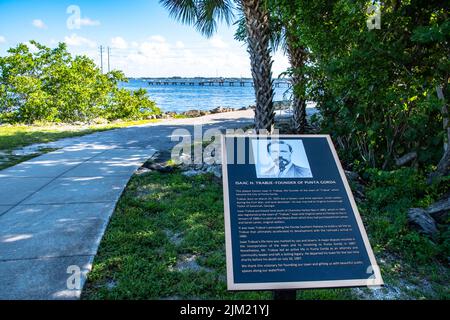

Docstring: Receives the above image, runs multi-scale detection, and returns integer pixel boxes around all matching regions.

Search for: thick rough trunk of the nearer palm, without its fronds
[241,0,275,133]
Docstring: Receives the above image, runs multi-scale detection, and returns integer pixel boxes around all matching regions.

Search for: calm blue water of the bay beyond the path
[121,79,289,112]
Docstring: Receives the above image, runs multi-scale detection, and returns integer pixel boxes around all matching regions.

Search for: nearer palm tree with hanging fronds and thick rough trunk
[160,0,275,133]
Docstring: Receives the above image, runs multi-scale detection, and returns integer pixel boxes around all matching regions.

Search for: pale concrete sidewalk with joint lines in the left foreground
[0,143,155,299]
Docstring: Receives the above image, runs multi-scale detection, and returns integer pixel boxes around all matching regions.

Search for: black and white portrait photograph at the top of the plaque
[252,139,313,178]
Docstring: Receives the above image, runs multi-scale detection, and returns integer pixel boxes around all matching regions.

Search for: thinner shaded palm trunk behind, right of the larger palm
[287,37,307,134]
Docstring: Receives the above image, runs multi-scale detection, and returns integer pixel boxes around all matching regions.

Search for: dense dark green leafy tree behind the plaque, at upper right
[282,0,448,169]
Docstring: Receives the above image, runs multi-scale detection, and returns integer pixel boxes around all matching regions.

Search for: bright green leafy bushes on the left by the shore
[0,41,160,124]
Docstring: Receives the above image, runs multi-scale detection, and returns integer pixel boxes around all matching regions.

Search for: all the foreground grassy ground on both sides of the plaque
[83,131,450,299]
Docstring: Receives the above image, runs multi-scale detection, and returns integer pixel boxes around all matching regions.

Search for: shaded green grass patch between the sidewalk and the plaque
[82,172,353,299]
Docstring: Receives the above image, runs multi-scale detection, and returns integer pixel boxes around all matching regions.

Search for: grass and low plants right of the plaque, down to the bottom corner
[359,168,450,299]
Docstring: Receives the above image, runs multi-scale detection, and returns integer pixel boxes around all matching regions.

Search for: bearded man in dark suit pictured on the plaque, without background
[263,140,312,178]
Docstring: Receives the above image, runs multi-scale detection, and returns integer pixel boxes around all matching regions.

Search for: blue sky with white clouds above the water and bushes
[0,0,289,77]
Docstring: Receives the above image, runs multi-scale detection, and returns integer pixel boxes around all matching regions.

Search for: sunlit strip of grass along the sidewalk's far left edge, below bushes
[0,120,157,170]
